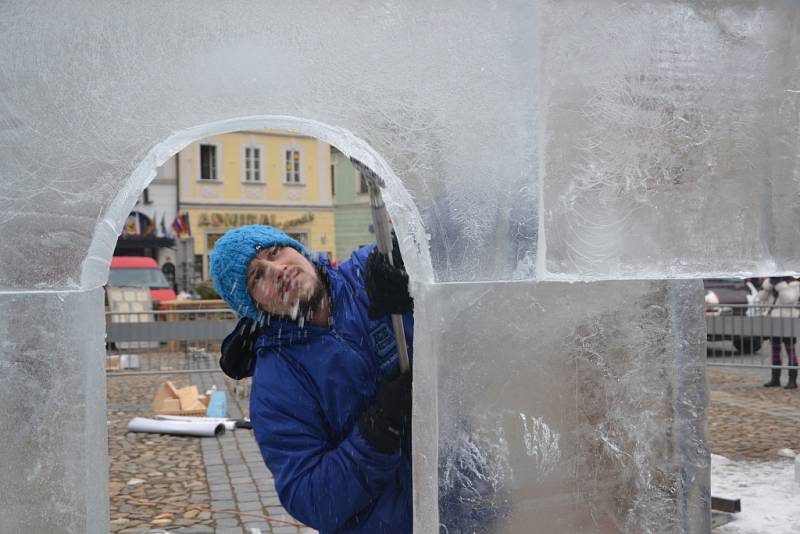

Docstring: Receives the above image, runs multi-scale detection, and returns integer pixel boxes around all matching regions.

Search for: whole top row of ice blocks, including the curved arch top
[0,0,800,288]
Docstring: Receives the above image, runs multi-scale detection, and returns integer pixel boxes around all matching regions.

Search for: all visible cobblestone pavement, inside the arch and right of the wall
[108,352,800,534]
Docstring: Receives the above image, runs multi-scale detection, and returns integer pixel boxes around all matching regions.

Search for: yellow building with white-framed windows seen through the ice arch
[178,130,336,279]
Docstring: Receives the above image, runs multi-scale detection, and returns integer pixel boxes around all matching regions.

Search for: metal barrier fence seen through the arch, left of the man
[106,309,237,377]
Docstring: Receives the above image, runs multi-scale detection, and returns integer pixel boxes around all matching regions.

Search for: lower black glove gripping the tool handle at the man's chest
[358,373,411,454]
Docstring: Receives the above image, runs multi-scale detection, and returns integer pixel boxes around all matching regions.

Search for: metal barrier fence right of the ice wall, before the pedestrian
[706,304,800,369]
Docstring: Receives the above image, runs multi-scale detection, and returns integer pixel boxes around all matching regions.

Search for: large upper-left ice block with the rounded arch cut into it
[0,0,536,288]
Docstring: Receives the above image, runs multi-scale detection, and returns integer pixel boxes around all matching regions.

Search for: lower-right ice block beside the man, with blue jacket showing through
[414,281,710,534]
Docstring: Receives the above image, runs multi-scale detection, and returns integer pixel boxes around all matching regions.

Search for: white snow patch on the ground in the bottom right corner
[711,454,800,534]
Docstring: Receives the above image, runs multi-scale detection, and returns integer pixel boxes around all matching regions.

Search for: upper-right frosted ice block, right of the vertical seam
[537,0,800,279]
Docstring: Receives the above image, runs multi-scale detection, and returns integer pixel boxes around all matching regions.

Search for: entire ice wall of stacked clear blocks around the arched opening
[0,0,800,532]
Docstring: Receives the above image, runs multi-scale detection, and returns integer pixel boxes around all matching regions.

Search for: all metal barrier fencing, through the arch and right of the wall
[106,304,800,377]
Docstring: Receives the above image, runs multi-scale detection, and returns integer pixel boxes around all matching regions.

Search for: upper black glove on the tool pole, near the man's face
[364,235,414,320]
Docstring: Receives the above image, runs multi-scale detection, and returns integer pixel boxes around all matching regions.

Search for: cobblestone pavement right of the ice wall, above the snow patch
[707,367,800,461]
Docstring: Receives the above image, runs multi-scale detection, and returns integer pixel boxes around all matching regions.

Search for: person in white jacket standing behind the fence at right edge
[758,276,800,389]
